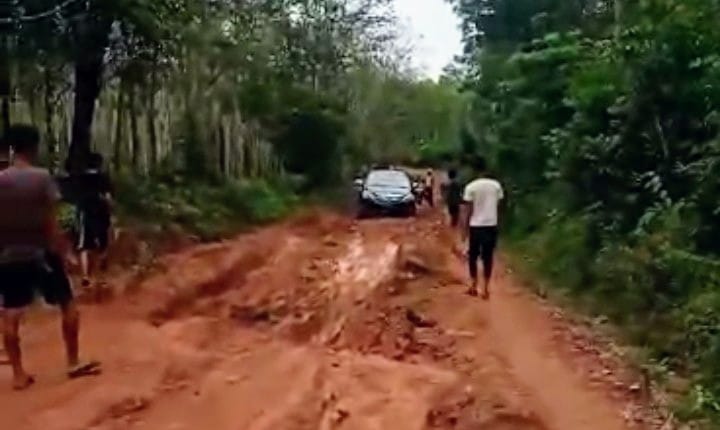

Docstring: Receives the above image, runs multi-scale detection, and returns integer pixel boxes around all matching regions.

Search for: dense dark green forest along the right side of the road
[454,0,720,422]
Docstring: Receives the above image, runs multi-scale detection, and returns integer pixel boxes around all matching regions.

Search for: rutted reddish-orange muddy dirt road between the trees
[0,209,664,430]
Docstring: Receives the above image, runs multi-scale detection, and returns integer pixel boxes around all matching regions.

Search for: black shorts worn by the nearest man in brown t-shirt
[0,254,73,309]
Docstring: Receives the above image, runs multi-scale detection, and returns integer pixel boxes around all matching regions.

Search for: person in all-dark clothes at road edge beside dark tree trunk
[77,153,113,287]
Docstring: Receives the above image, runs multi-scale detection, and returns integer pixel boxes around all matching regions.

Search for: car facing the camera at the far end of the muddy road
[358,169,416,217]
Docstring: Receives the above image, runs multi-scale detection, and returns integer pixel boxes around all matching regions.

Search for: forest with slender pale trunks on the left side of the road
[0,0,463,235]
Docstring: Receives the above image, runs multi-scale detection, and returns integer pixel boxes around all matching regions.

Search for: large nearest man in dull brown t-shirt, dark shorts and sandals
[0,125,99,390]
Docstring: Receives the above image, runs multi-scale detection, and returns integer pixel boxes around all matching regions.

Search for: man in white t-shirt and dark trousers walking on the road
[460,157,504,299]
